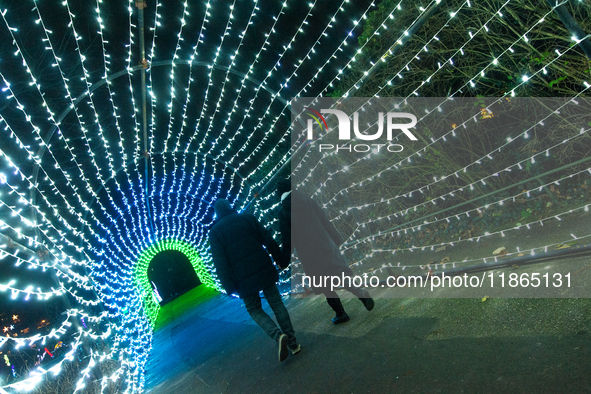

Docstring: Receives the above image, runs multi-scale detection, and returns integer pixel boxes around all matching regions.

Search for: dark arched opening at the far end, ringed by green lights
[148,250,201,305]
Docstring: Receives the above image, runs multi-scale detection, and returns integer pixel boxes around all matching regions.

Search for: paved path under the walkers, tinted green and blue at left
[146,208,591,394]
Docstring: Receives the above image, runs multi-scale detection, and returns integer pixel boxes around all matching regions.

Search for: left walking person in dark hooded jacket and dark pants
[209,198,301,361]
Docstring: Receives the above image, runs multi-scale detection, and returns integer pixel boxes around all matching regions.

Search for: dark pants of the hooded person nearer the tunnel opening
[242,285,297,347]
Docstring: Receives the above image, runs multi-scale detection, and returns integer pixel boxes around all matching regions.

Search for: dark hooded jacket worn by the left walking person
[209,199,281,298]
